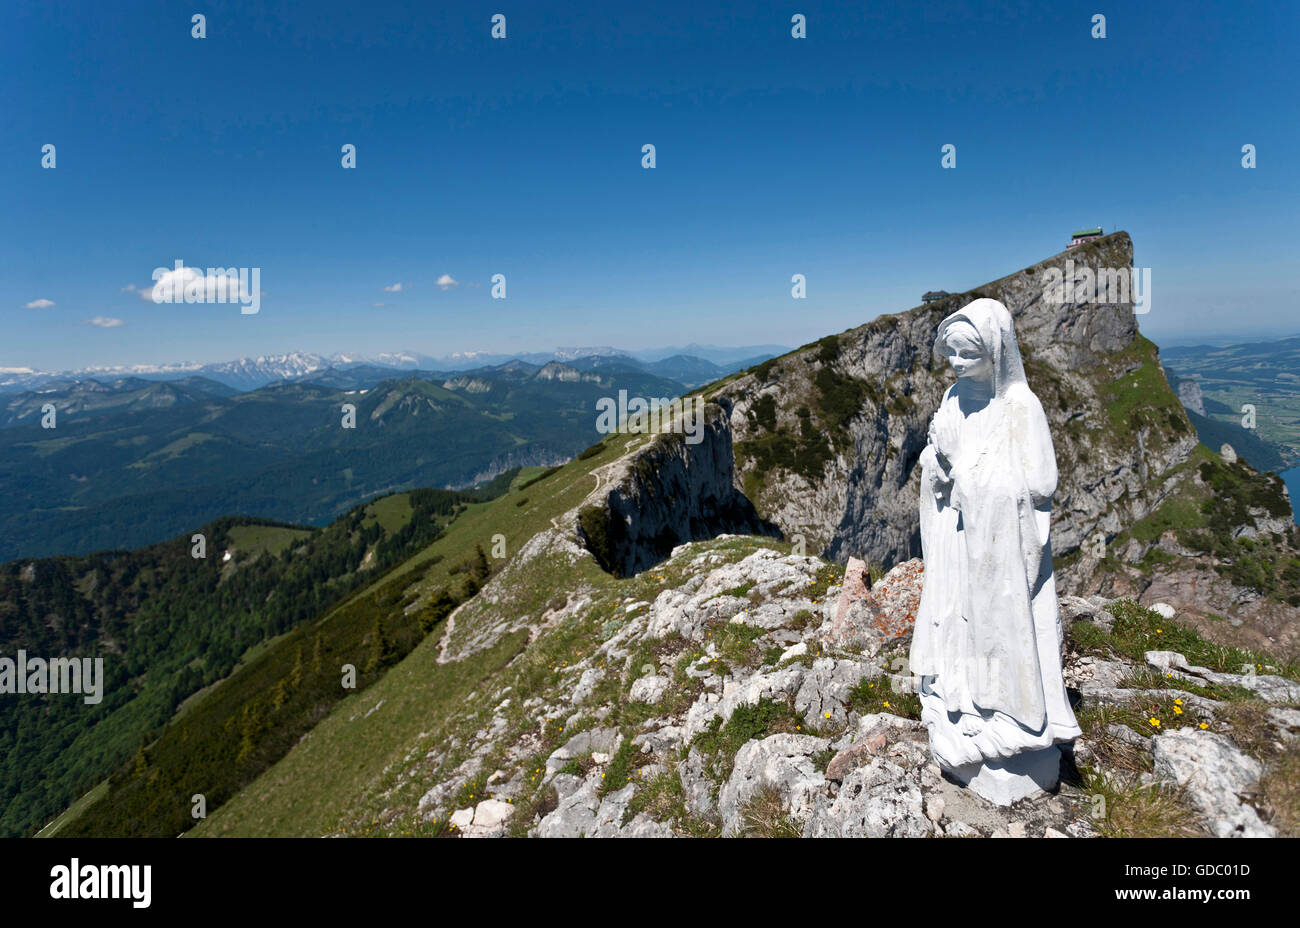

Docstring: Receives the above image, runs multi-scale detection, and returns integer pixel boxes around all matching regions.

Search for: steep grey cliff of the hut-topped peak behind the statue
[577,233,1300,655]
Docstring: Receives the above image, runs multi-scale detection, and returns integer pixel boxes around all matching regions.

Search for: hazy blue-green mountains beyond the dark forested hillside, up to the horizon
[0,354,774,561]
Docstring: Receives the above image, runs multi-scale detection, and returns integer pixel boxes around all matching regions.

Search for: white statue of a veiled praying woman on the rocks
[911,299,1080,806]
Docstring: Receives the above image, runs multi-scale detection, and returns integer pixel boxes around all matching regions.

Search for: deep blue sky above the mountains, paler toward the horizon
[0,0,1300,368]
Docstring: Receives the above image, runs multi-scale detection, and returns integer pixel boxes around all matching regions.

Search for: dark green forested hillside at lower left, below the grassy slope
[0,480,488,834]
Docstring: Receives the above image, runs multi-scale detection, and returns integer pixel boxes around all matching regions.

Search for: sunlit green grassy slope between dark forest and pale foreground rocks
[190,537,795,837]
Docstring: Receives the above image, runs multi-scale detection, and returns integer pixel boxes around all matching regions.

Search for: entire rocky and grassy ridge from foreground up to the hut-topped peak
[27,235,1300,837]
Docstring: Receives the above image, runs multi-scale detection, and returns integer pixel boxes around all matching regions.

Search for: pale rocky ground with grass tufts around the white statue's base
[400,535,1300,837]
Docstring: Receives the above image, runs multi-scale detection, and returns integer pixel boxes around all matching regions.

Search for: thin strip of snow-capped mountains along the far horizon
[0,344,789,394]
